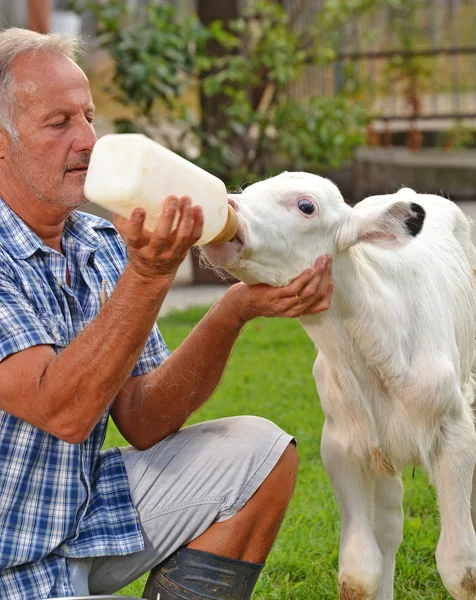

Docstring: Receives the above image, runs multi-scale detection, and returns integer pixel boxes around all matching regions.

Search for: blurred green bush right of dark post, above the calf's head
[186,0,366,184]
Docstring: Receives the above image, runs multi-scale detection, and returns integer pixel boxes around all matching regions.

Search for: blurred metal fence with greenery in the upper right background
[282,0,476,121]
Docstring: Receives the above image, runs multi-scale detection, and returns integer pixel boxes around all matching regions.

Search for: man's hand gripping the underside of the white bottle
[114,196,203,279]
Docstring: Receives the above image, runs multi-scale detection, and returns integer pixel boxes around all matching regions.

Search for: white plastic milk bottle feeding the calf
[84,133,238,246]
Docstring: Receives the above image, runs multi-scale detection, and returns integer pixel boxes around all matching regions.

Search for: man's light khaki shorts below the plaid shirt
[69,417,293,596]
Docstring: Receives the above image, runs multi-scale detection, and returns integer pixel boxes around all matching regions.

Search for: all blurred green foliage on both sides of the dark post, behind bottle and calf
[70,0,371,186]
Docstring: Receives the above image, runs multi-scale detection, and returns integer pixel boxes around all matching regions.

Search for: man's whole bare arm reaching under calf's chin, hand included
[112,257,332,449]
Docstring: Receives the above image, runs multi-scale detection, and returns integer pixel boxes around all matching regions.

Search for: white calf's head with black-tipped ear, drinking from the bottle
[203,172,425,286]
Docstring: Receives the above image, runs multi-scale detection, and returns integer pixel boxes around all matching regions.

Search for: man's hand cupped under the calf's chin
[227,256,334,322]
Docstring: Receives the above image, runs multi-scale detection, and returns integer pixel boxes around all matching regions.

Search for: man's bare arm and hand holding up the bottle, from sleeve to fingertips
[0,198,202,443]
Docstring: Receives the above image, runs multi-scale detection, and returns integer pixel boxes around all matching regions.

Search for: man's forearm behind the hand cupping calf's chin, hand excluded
[113,298,243,448]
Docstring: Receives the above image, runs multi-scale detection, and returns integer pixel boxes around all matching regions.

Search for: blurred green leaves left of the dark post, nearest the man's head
[68,0,205,117]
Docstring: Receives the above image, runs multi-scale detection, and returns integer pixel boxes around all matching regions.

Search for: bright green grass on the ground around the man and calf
[106,309,450,600]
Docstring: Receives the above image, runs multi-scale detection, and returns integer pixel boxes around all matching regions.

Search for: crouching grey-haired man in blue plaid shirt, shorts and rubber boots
[0,29,332,600]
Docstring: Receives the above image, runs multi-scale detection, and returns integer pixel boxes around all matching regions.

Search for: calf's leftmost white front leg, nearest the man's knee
[321,422,382,600]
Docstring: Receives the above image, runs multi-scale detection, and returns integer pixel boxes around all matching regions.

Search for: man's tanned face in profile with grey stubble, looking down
[7,53,97,209]
